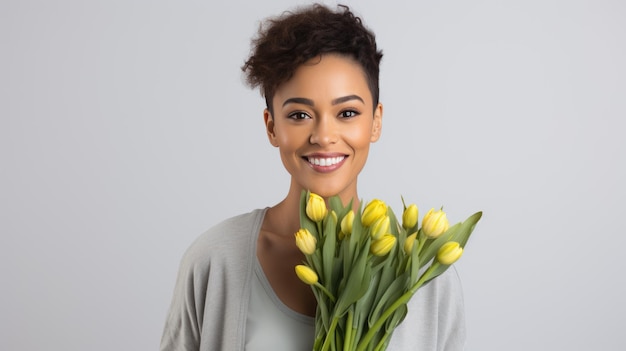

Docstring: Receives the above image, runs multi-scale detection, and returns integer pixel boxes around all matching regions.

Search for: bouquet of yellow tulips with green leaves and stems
[295,192,482,351]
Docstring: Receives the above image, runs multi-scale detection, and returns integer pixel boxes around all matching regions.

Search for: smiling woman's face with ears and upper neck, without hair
[264,54,382,204]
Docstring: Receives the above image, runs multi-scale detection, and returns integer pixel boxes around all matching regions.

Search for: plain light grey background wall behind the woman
[0,0,626,351]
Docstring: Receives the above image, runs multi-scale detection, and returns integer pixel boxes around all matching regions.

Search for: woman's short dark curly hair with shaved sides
[241,4,383,113]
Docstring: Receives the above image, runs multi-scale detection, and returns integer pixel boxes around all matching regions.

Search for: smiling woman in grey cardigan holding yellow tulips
[161,5,465,351]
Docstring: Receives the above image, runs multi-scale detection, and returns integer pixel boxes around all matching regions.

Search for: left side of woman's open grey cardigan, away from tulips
[161,210,265,350]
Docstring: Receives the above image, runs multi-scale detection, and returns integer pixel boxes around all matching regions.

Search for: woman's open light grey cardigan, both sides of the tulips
[161,209,465,351]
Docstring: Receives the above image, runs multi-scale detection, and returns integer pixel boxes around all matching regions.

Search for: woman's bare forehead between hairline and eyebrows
[273,54,372,107]
